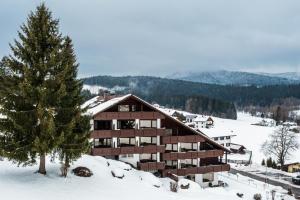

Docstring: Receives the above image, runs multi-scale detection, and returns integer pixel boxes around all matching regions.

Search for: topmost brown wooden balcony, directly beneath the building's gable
[94,112,165,120]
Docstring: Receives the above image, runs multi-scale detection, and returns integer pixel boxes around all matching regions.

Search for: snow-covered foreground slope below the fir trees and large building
[0,155,294,200]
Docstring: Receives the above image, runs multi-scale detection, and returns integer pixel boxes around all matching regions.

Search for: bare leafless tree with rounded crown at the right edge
[262,126,299,169]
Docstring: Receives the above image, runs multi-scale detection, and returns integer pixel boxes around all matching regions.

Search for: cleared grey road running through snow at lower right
[229,168,300,199]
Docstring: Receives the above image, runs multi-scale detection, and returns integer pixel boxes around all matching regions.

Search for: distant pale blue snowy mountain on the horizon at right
[167,70,300,86]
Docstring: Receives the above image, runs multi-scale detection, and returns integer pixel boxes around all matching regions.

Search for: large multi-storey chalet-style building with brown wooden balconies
[83,94,230,186]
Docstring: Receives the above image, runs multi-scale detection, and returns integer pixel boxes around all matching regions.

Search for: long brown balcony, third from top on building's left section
[91,145,165,156]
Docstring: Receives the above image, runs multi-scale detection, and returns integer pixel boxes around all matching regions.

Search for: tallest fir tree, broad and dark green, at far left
[0,4,88,174]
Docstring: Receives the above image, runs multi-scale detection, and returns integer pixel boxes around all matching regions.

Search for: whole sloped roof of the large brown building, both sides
[83,94,231,152]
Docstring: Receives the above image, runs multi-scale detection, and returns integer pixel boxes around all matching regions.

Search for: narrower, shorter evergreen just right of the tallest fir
[55,37,90,176]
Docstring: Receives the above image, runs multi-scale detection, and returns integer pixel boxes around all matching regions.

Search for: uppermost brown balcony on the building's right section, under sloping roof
[162,135,205,144]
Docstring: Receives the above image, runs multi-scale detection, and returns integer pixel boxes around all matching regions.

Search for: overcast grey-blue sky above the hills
[0,0,300,77]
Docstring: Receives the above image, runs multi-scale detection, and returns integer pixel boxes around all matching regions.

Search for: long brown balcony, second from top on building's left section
[91,128,167,139]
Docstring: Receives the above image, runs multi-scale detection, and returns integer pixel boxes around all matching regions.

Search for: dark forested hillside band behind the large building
[83,76,300,108]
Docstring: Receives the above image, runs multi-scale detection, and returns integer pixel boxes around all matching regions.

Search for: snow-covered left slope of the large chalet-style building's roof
[82,94,131,115]
